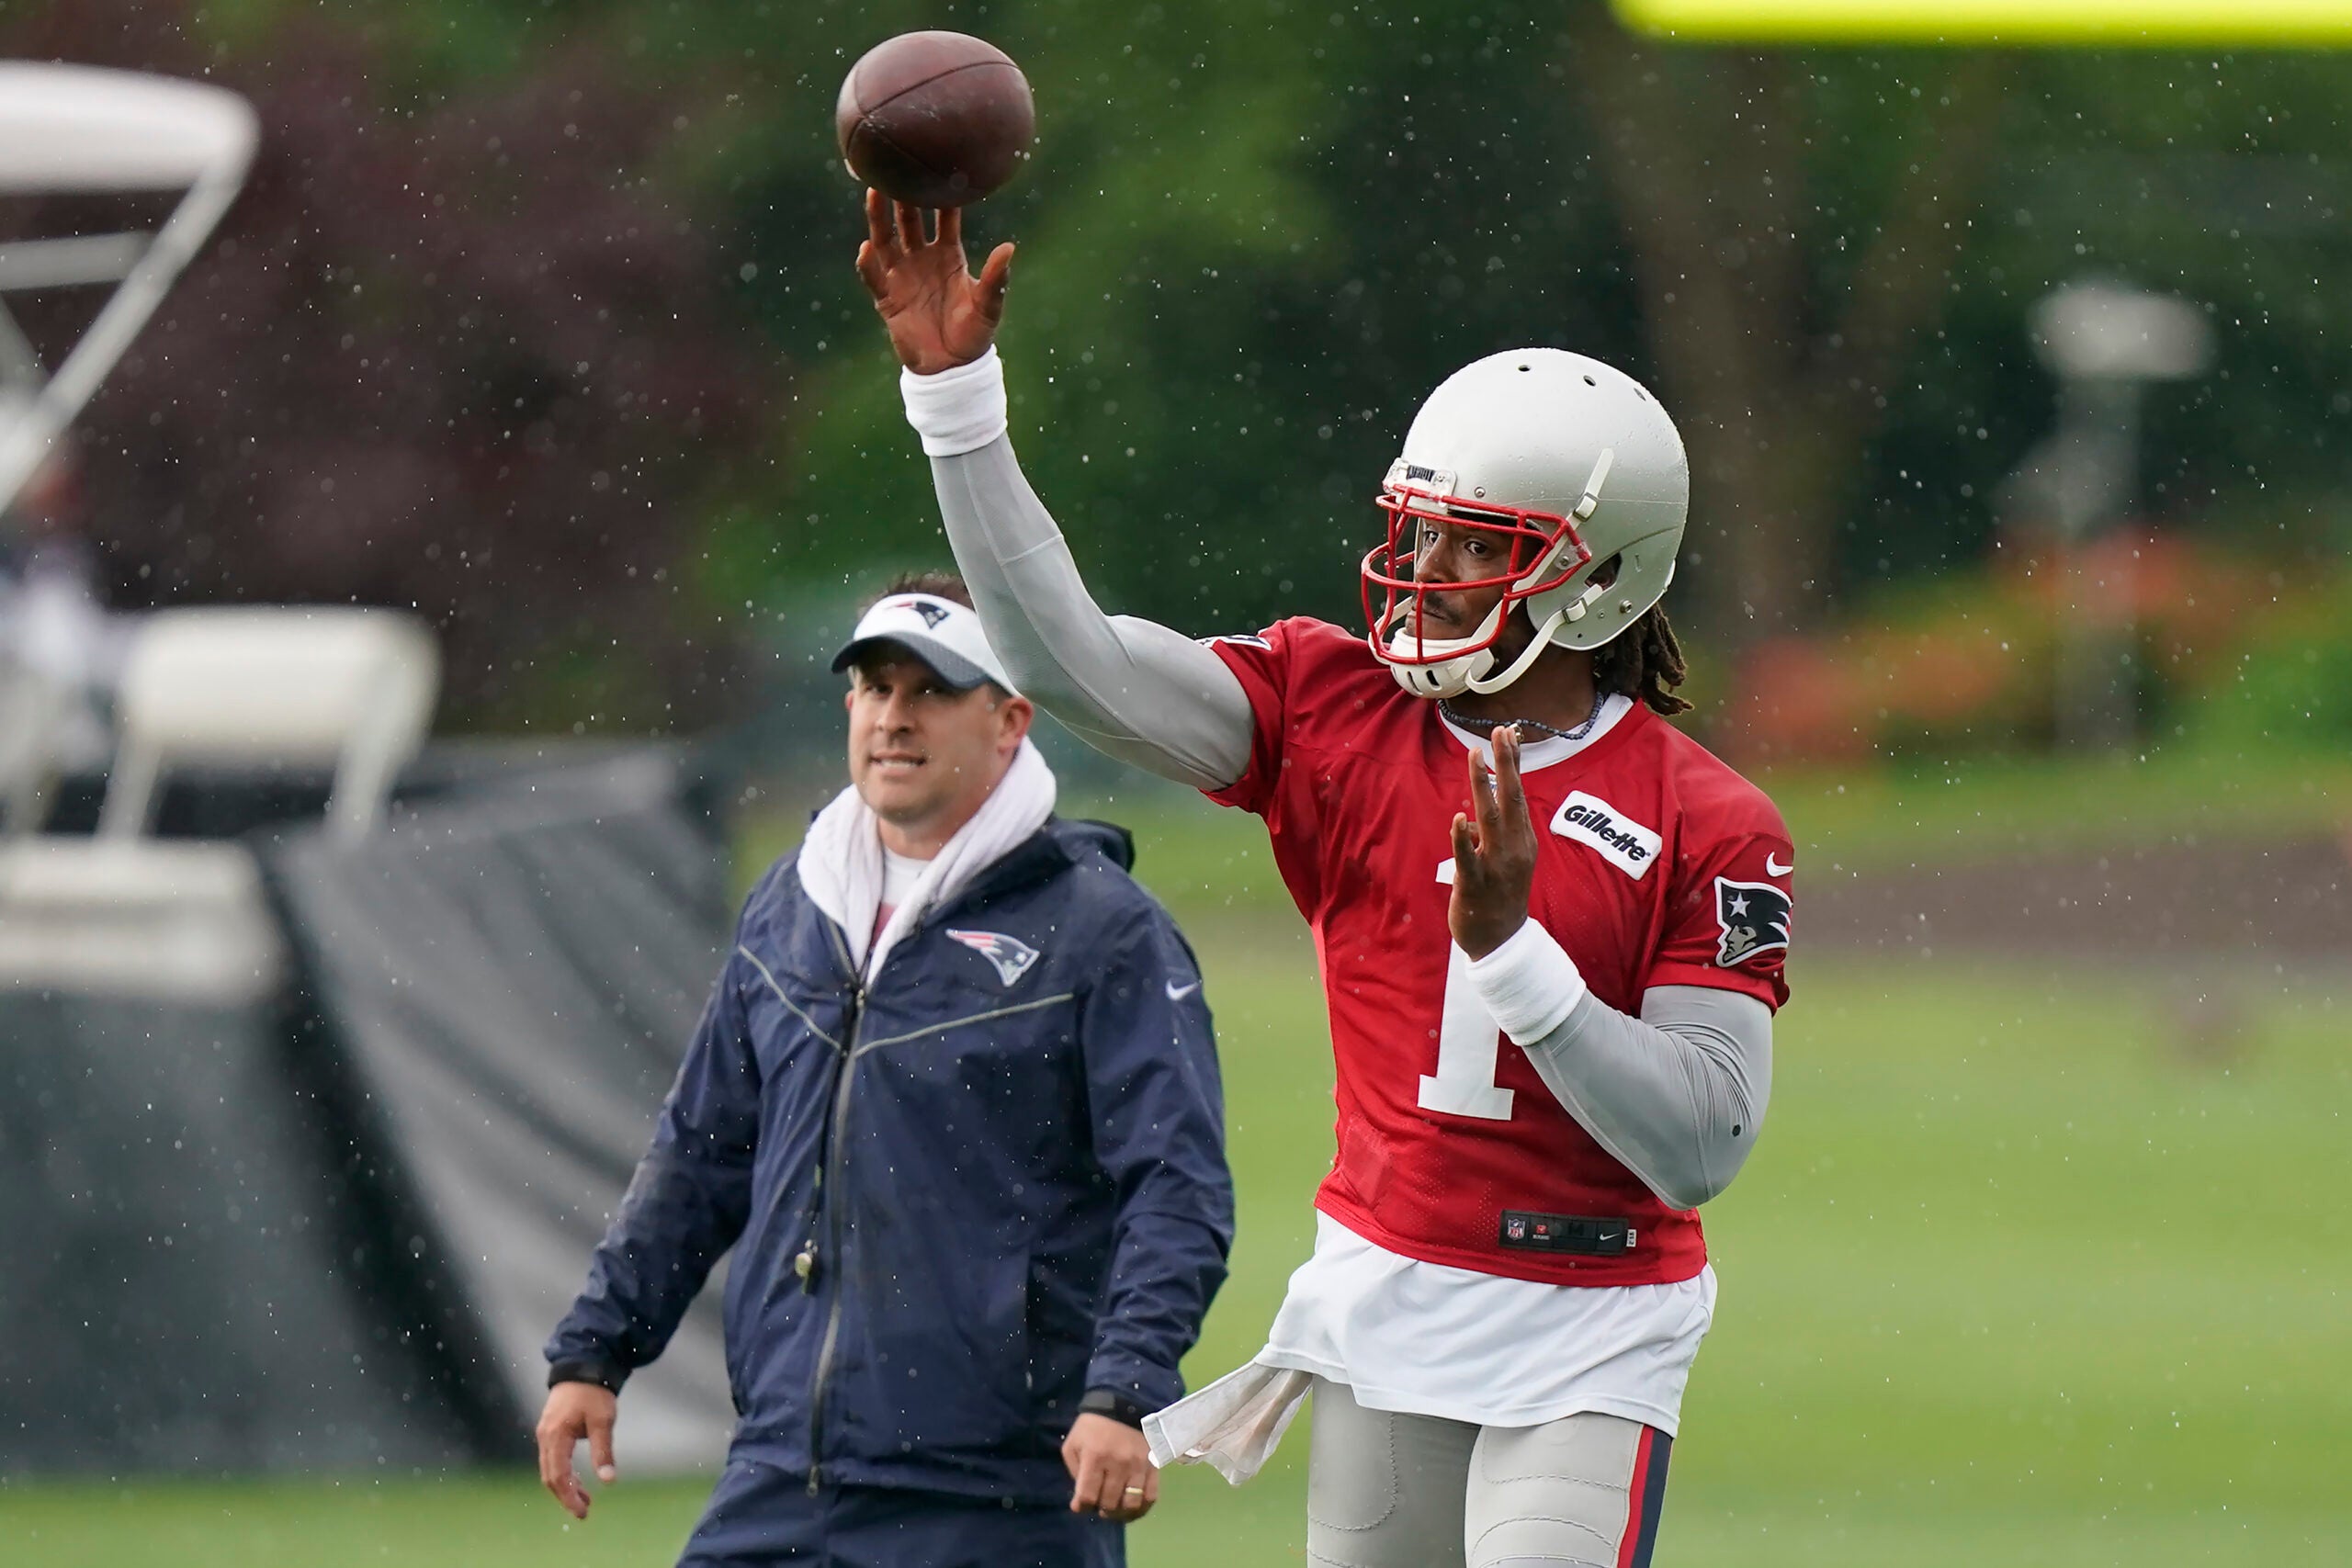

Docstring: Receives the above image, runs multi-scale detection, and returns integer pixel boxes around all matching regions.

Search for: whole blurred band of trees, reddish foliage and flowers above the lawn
[0,0,2352,755]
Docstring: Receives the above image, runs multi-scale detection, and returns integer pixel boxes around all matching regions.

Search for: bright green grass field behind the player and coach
[0,780,2352,1568]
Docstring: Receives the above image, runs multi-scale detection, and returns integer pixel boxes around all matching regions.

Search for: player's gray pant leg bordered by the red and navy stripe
[1463,1413,1642,1568]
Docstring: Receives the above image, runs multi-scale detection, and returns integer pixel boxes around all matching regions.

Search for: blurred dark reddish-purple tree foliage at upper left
[0,0,767,727]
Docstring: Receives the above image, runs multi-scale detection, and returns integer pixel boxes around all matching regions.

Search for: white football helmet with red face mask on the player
[1364,348,1691,698]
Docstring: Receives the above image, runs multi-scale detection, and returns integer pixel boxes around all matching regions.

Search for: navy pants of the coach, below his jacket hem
[677,1460,1126,1568]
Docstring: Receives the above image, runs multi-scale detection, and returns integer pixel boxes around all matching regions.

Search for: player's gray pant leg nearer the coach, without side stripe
[1307,1378,1479,1568]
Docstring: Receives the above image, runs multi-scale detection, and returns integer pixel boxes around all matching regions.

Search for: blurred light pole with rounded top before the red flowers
[2032,282,2213,748]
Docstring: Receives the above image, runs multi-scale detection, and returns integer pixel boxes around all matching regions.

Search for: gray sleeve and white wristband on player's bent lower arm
[1470,919,1771,1208]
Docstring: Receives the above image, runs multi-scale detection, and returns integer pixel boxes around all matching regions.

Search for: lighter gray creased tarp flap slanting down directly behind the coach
[264,752,731,1467]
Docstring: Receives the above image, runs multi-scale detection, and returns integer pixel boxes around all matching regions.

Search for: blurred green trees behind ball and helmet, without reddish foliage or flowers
[18,0,2352,738]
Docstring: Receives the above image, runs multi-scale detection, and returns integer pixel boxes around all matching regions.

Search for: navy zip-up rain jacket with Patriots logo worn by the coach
[546,818,1232,1502]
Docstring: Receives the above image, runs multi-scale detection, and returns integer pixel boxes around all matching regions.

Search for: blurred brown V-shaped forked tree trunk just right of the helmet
[1562,24,2013,642]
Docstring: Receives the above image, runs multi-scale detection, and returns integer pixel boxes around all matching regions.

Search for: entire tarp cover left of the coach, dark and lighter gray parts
[0,748,731,1474]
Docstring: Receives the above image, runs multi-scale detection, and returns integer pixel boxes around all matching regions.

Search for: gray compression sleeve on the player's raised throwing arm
[932,434,1253,790]
